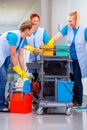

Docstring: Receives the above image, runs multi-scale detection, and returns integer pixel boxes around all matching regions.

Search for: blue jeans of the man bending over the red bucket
[0,57,9,109]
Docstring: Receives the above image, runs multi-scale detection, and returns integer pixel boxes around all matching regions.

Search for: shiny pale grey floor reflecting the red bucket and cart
[0,95,87,130]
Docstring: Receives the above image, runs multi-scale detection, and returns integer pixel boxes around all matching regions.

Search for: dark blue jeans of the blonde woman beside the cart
[72,60,83,104]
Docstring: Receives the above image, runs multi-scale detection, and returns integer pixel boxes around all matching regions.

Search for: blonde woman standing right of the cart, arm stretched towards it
[48,11,87,107]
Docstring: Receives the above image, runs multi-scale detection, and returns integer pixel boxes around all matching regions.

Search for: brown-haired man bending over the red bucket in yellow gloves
[0,20,34,112]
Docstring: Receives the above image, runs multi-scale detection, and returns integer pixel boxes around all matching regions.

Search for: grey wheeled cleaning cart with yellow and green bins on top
[26,45,74,115]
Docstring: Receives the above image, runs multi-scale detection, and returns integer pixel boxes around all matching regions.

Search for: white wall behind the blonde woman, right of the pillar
[51,0,87,35]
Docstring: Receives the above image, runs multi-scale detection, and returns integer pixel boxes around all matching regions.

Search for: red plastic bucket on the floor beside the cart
[10,93,32,113]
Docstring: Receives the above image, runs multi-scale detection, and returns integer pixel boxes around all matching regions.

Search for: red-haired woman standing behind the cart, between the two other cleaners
[25,13,50,81]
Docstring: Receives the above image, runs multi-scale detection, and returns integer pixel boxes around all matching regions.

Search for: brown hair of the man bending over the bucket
[19,20,34,32]
